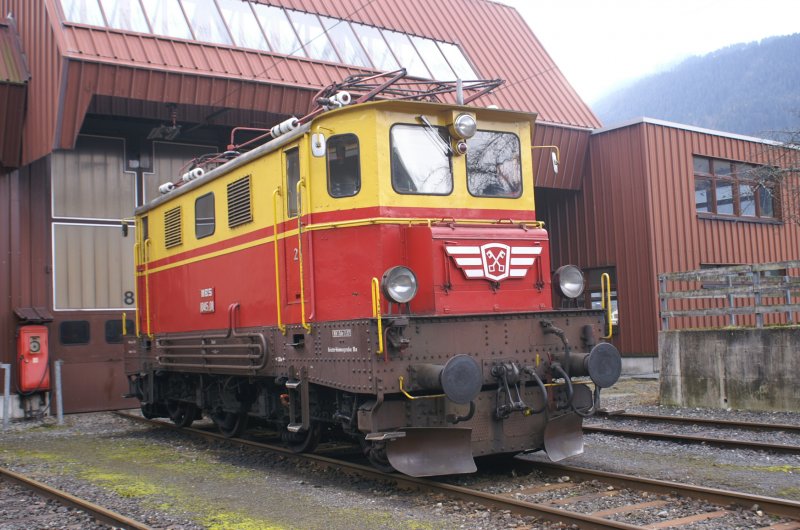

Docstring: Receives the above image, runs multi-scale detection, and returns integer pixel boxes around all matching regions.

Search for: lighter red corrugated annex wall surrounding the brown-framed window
[638,123,800,328]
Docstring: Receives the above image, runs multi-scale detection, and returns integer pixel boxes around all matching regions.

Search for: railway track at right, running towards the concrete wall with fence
[583,413,800,454]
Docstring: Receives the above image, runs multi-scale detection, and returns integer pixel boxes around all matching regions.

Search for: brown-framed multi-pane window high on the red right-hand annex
[693,156,776,220]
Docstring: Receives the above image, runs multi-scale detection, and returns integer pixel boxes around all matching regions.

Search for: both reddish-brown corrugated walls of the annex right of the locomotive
[552,122,800,355]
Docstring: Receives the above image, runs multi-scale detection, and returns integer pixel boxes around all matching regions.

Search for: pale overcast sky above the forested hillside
[500,0,800,104]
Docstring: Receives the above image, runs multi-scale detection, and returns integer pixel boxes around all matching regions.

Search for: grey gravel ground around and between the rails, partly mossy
[0,379,800,530]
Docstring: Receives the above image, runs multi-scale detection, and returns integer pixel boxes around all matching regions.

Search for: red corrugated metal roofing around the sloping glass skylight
[53,0,600,127]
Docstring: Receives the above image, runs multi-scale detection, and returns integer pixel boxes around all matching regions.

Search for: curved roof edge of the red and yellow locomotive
[134,99,537,215]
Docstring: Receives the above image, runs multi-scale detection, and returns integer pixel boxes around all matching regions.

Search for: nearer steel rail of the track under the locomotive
[114,412,642,530]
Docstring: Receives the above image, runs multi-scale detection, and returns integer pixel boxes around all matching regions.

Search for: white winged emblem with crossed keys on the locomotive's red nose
[445,243,542,282]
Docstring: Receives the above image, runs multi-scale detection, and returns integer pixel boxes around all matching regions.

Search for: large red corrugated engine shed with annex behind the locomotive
[0,0,800,416]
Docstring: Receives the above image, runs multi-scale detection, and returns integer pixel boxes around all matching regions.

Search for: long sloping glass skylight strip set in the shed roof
[61,0,478,81]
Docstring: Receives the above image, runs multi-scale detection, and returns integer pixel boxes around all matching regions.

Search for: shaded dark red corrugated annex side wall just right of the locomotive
[537,124,657,355]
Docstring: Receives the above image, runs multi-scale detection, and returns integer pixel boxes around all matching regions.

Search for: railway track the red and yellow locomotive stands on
[117,413,800,530]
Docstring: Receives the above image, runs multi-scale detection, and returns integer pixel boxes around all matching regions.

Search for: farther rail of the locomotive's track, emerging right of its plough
[518,459,800,520]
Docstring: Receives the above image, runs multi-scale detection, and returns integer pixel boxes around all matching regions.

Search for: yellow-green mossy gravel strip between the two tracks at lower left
[0,426,434,530]
